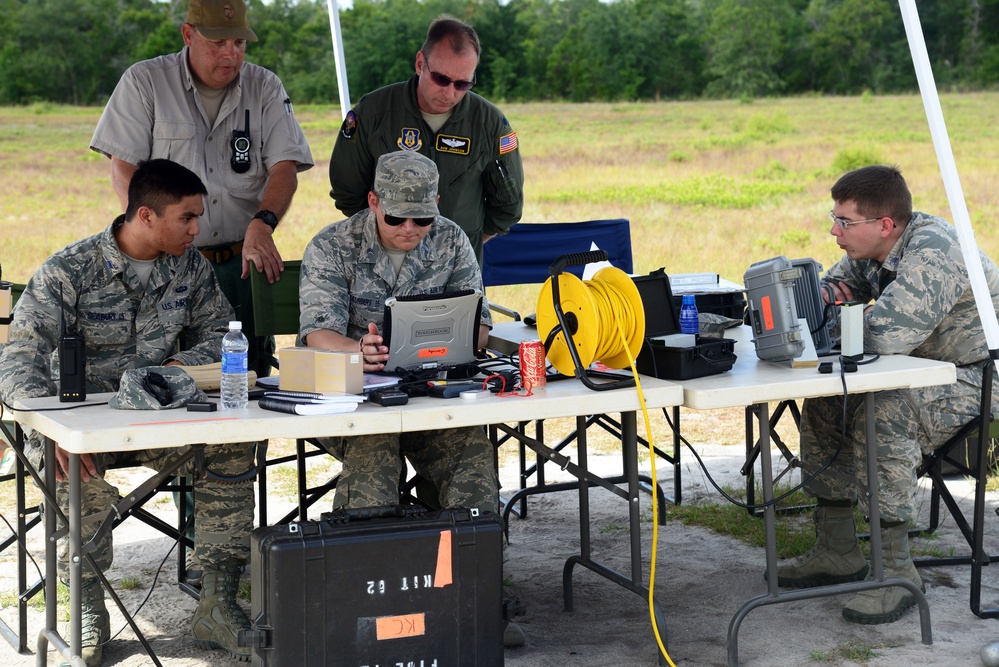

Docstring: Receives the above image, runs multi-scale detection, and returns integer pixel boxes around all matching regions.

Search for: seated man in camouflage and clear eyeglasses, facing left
[778,166,999,624]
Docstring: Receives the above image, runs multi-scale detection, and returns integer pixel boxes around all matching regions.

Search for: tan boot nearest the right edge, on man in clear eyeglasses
[843,522,926,625]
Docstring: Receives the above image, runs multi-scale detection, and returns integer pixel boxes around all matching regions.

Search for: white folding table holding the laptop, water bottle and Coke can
[13,380,683,667]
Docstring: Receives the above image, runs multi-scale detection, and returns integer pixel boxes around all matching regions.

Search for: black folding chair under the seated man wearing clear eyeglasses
[909,360,999,618]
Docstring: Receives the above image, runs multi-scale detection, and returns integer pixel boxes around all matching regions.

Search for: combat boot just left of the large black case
[191,559,251,662]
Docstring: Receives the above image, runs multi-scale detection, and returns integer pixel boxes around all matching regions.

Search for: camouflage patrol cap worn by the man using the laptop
[374,151,439,218]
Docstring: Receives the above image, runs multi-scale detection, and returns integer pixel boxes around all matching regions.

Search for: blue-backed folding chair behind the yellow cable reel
[482,218,680,525]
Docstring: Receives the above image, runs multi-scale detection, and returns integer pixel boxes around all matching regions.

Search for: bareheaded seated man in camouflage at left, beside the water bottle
[0,160,253,667]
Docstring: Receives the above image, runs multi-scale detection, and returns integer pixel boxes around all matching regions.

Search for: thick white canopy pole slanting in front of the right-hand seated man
[898,0,999,351]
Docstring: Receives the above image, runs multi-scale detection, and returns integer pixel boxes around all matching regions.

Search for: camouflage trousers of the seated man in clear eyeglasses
[801,368,982,521]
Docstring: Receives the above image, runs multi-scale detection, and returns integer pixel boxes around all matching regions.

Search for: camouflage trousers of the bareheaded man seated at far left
[56,442,254,581]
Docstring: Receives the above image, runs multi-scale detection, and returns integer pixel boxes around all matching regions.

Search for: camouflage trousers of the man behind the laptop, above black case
[319,426,499,512]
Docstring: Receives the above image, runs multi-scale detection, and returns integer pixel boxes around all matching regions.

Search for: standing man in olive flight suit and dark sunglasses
[330,16,524,264]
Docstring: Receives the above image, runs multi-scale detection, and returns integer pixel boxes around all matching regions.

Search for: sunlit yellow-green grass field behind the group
[0,93,999,460]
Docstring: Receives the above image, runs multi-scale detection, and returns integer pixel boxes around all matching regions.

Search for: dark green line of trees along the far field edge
[0,0,999,105]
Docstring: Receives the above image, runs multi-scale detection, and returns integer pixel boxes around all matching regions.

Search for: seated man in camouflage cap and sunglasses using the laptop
[299,151,499,512]
